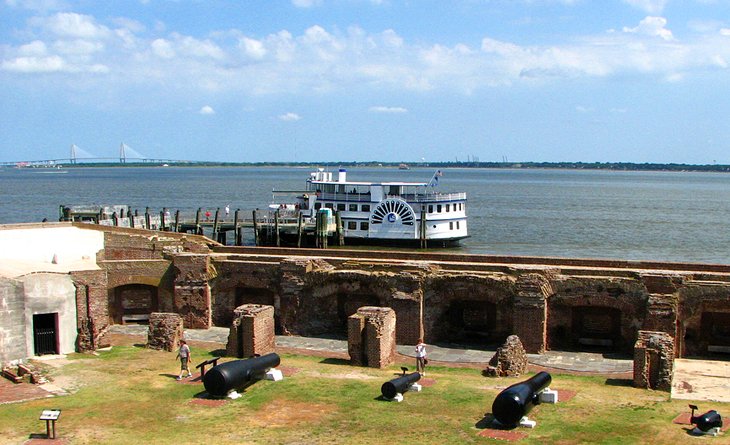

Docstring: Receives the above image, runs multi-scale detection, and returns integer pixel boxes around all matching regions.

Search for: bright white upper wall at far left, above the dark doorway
[0,226,104,265]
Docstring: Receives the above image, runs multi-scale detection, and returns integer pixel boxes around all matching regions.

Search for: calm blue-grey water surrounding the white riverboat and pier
[0,167,730,264]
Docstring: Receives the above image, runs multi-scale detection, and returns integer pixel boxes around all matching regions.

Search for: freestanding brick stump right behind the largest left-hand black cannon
[226,304,276,358]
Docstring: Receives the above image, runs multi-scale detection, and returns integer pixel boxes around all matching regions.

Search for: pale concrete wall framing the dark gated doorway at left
[21,273,77,357]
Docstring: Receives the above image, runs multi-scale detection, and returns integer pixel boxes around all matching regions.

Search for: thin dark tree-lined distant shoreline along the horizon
[2,161,730,173]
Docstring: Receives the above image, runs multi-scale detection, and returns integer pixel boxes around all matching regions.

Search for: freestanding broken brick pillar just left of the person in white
[347,306,395,369]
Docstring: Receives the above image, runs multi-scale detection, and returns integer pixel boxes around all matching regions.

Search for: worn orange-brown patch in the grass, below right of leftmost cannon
[245,400,337,428]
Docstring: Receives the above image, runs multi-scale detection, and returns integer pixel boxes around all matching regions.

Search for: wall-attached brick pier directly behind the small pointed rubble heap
[513,273,553,354]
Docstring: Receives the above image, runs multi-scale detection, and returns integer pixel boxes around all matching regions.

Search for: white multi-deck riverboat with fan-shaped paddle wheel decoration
[270,168,469,246]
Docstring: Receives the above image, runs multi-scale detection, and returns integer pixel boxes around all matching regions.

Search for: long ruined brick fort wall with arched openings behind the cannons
[0,224,730,368]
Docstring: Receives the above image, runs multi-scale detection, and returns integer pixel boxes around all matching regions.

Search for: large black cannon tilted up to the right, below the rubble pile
[492,371,552,426]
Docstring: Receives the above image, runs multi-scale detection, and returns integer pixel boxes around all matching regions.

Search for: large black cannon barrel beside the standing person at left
[203,352,281,397]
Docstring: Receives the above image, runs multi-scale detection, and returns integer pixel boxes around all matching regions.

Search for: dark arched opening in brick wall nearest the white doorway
[109,284,159,324]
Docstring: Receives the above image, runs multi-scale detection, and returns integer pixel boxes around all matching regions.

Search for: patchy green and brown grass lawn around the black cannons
[0,336,730,445]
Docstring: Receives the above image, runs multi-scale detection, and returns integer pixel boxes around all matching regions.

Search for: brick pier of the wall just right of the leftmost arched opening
[172,254,215,329]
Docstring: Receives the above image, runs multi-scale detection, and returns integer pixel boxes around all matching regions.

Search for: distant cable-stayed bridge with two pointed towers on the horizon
[0,142,192,167]
